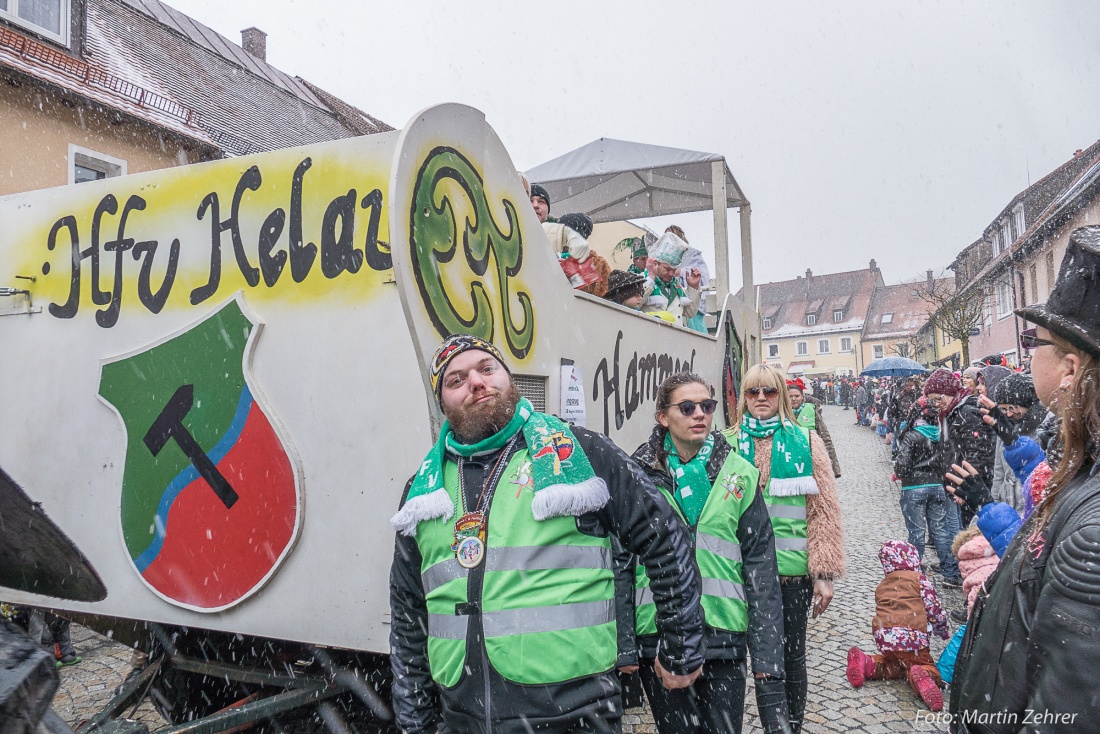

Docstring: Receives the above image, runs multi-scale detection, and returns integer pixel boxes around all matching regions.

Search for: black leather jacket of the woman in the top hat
[950,462,1100,733]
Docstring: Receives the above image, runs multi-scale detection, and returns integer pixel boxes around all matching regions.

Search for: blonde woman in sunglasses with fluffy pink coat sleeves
[725,364,844,732]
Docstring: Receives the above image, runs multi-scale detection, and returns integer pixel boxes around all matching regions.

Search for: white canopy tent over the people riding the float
[527,138,755,306]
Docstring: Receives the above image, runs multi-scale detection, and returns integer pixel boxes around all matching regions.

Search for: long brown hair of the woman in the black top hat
[1037,333,1100,524]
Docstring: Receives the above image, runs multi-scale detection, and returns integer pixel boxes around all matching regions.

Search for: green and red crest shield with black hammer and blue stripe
[99,299,300,612]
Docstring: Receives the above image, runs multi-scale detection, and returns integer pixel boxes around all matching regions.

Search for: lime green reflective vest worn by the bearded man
[416,449,617,688]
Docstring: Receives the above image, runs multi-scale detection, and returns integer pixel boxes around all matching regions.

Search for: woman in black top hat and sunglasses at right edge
[947,227,1100,733]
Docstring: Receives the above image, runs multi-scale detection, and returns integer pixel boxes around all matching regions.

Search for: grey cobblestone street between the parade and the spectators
[47,406,963,734]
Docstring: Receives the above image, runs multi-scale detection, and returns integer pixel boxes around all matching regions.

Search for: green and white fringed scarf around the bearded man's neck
[389,397,611,537]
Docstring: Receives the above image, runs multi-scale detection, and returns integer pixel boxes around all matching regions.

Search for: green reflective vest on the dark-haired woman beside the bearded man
[635,449,760,635]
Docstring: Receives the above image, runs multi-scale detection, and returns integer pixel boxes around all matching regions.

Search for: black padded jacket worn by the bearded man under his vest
[389,427,703,734]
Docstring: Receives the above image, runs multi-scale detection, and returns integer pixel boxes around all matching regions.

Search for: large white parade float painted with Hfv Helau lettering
[0,105,759,732]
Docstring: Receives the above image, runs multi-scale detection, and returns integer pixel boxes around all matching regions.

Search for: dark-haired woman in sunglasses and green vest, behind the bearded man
[627,372,790,734]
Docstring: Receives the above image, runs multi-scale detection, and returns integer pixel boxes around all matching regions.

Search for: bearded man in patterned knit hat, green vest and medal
[389,335,703,734]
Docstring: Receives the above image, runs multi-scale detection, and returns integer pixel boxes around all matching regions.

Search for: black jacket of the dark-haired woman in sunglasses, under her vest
[619,428,784,678]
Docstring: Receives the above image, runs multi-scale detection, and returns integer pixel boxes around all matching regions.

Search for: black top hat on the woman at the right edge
[1015,226,1100,355]
